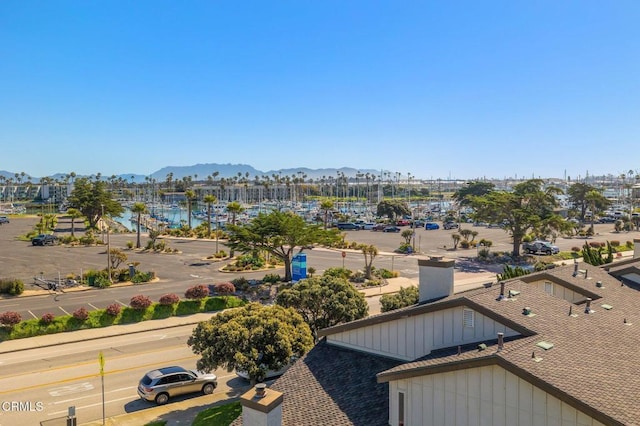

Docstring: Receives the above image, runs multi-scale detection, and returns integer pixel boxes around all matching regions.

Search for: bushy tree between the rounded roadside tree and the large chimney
[276,276,369,339]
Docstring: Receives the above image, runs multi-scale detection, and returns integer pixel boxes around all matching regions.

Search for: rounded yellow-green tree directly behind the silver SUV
[187,303,313,382]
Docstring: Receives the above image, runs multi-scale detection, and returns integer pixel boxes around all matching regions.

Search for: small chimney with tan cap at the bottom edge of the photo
[240,383,284,426]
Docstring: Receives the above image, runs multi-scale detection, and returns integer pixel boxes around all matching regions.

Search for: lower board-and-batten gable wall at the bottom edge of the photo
[389,365,604,426]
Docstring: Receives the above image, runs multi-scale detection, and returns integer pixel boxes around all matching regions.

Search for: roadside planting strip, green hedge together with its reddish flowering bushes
[0,286,245,342]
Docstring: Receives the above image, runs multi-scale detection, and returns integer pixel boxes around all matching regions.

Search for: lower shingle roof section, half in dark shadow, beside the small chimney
[232,341,401,426]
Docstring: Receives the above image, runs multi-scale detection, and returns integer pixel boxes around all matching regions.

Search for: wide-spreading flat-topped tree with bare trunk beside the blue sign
[228,211,340,282]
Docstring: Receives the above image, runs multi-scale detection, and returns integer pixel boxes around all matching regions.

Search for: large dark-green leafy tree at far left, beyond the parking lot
[69,177,124,228]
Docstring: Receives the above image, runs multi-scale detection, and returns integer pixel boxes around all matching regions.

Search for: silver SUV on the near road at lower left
[138,366,218,405]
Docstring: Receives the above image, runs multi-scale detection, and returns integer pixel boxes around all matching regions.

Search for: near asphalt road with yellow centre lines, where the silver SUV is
[0,326,249,426]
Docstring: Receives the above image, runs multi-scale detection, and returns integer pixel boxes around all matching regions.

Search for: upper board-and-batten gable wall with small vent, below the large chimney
[327,307,518,361]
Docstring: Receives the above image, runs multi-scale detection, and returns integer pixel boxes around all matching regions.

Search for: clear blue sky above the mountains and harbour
[0,0,640,178]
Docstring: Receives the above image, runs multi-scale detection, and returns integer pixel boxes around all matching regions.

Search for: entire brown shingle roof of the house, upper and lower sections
[234,264,640,425]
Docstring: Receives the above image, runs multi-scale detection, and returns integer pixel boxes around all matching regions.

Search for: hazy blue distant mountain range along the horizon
[0,163,381,183]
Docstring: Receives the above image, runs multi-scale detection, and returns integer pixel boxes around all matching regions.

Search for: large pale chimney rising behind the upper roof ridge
[418,256,455,303]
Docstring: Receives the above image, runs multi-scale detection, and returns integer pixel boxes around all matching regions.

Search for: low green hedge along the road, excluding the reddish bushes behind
[0,296,245,342]
